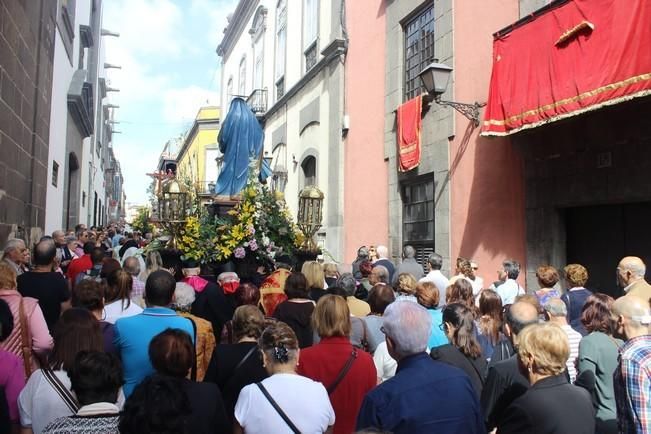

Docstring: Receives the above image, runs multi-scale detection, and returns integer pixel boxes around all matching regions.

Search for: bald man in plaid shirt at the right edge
[612,295,651,433]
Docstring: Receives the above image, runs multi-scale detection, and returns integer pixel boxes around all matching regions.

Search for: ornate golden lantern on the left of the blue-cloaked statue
[158,179,190,248]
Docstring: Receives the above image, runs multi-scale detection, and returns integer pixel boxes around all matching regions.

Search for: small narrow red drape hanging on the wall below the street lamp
[396,95,423,172]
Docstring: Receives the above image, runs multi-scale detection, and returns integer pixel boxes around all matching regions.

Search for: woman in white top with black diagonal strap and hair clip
[233,322,335,434]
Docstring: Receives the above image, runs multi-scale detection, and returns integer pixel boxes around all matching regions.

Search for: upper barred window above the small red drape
[404,5,434,101]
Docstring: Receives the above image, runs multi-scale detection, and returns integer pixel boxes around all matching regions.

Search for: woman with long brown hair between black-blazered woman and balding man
[477,289,505,361]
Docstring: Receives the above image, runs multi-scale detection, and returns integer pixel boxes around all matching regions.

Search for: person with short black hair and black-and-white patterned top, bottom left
[43,351,123,434]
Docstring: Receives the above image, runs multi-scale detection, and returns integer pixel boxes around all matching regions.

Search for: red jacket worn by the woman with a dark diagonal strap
[298,337,377,434]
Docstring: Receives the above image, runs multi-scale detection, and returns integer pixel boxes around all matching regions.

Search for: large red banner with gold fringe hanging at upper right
[481,0,651,136]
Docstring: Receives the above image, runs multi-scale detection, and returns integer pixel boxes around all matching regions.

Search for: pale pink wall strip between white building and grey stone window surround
[341,0,389,264]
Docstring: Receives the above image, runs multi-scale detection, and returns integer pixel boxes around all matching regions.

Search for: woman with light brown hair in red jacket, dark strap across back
[298,295,377,434]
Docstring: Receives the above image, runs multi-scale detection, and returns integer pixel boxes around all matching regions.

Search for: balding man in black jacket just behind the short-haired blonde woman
[481,301,538,431]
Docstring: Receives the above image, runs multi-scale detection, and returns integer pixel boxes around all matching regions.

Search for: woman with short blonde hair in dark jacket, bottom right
[498,323,595,434]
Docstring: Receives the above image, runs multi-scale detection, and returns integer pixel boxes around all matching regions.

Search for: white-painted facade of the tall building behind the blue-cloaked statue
[222,0,344,259]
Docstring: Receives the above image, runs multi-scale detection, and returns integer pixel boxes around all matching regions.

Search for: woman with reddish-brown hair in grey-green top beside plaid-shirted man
[575,293,624,434]
